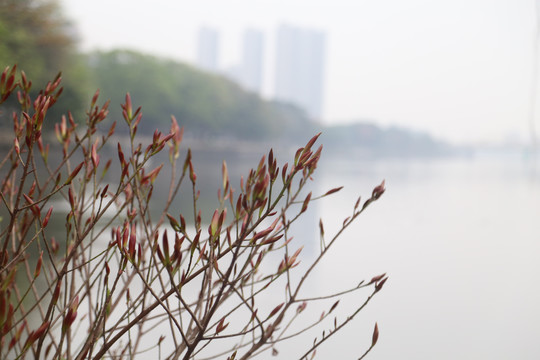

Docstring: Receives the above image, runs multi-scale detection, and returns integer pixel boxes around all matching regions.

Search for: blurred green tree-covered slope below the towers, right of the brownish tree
[88,50,312,139]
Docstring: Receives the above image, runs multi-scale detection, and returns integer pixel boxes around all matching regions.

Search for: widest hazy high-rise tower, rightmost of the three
[275,25,326,120]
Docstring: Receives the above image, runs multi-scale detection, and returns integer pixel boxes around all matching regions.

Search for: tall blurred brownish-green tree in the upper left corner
[0,0,89,126]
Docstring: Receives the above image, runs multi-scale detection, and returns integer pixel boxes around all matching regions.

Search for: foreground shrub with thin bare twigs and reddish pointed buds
[0,67,387,359]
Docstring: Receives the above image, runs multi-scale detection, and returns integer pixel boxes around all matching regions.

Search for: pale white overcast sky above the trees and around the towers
[60,0,540,144]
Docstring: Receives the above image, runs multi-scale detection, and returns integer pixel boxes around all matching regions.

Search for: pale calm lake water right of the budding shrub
[304,155,540,360]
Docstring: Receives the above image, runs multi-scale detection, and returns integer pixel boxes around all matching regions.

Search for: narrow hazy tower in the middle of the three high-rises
[240,29,264,94]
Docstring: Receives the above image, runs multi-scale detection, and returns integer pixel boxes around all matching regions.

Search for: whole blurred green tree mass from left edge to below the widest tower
[0,0,314,139]
